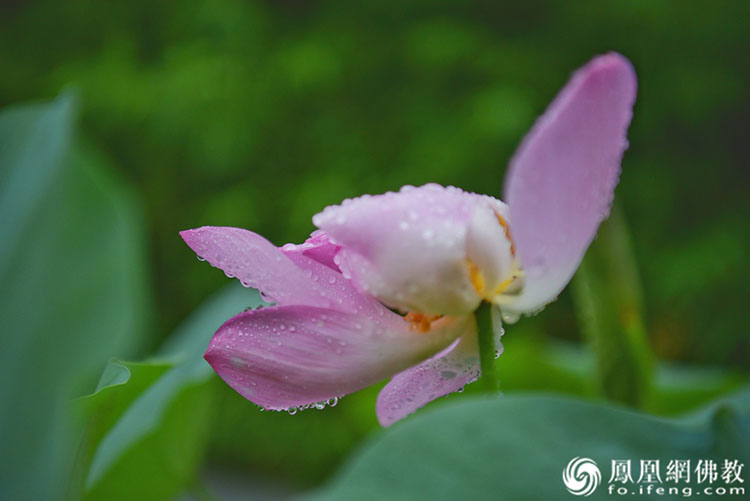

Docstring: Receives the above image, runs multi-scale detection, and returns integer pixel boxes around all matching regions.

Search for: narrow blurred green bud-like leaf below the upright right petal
[572,206,653,407]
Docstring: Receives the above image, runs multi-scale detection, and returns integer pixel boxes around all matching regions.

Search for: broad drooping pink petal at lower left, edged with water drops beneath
[205,306,471,410]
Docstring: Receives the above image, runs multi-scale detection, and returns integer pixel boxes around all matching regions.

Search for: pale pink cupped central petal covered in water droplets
[313,184,499,315]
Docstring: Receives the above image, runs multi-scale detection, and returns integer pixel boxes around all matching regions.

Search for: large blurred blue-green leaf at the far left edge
[0,95,148,500]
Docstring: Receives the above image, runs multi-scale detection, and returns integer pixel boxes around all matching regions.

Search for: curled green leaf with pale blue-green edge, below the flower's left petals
[78,286,262,500]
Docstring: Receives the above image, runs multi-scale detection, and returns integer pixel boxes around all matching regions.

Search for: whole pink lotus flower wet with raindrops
[181,53,636,426]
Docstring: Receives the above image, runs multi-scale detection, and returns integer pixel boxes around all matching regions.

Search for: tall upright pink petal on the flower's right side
[504,53,636,312]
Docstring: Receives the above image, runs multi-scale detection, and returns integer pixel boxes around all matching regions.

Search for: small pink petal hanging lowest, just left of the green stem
[376,322,480,426]
